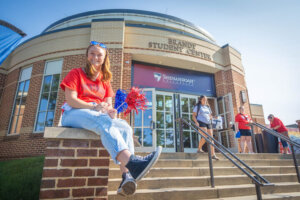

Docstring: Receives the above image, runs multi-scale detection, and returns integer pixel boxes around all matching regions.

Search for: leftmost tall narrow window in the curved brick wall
[8,67,32,135]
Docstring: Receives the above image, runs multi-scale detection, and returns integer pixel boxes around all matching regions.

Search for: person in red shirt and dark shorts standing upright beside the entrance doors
[235,106,253,153]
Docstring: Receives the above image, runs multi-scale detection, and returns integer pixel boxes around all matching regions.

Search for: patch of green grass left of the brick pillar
[0,156,44,200]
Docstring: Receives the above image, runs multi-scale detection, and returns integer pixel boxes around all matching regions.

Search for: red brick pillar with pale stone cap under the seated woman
[40,127,109,200]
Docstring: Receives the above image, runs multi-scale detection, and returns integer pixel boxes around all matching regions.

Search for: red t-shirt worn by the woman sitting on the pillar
[60,68,114,103]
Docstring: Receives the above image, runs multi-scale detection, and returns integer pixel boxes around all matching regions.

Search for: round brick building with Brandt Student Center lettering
[0,9,258,159]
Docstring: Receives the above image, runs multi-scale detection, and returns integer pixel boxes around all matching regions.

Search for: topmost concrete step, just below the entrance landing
[136,152,300,159]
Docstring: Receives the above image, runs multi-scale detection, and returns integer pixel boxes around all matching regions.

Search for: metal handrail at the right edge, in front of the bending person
[249,122,300,183]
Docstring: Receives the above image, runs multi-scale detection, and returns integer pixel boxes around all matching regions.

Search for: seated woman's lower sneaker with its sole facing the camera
[117,173,136,196]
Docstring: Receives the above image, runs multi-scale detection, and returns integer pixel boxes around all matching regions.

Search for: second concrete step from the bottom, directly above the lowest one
[108,174,297,191]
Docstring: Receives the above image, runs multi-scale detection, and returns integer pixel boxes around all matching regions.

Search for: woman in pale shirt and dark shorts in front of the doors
[193,95,219,160]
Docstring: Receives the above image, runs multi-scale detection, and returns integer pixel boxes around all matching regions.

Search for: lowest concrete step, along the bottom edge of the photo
[108,182,300,200]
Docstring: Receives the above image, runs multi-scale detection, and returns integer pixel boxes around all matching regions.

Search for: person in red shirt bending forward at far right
[268,114,289,154]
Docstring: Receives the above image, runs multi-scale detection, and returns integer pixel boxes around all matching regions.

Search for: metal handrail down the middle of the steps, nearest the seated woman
[177,118,274,200]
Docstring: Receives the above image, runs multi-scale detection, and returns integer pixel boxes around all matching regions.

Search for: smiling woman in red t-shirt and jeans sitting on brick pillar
[60,41,162,196]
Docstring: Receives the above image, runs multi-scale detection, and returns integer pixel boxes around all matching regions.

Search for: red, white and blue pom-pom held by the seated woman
[115,87,147,116]
